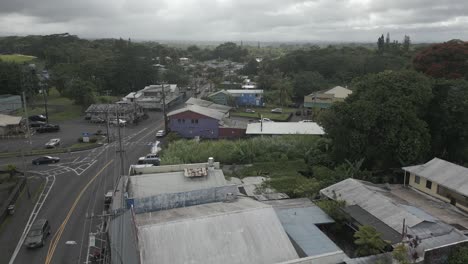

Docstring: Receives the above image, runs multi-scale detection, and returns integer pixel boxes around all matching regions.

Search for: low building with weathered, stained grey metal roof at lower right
[320,178,468,263]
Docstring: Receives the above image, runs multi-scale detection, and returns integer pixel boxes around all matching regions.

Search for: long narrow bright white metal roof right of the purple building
[245,122,325,135]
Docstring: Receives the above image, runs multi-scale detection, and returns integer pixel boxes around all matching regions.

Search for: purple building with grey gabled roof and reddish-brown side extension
[168,105,247,139]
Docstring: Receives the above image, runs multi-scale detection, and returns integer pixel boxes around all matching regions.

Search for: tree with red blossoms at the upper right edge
[413,40,468,79]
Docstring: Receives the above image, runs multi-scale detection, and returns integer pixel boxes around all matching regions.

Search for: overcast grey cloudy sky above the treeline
[0,0,468,43]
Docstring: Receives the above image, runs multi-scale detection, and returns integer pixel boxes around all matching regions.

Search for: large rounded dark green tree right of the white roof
[320,71,432,169]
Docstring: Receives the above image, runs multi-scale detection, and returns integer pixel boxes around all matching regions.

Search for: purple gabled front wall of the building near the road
[169,111,219,138]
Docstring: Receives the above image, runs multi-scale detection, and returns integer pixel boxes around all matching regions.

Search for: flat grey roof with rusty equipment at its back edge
[128,169,228,198]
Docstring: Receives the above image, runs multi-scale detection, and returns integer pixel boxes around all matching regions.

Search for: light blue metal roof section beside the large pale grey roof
[276,205,342,256]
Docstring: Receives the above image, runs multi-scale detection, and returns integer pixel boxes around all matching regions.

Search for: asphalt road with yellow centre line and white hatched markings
[5,112,163,264]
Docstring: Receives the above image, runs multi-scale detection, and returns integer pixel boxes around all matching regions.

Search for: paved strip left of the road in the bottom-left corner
[0,176,45,263]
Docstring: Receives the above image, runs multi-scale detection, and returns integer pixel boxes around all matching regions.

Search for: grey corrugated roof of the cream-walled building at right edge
[403,158,468,196]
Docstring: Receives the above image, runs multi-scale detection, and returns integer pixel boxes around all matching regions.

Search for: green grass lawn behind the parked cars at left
[15,88,83,123]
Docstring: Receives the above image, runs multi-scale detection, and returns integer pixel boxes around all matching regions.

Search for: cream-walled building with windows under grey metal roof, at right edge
[403,158,468,212]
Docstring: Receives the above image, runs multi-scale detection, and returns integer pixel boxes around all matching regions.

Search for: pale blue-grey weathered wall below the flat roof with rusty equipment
[127,185,237,214]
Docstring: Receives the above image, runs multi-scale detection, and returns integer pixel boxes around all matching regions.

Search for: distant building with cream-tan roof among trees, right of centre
[304,86,353,108]
